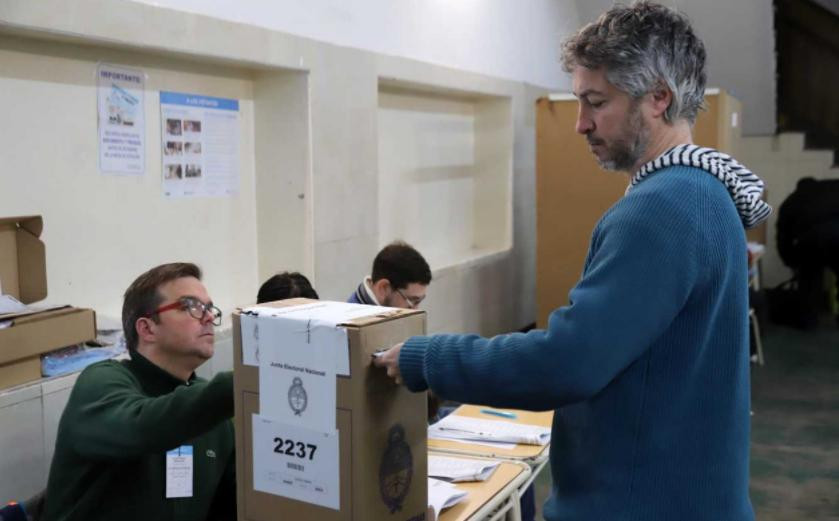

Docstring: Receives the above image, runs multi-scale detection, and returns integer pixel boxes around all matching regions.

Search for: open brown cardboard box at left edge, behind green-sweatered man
[0,216,96,388]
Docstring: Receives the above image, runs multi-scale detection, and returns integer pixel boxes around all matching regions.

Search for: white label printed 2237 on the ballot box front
[253,414,341,510]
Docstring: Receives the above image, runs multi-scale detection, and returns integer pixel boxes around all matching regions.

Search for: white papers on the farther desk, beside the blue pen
[428,414,551,445]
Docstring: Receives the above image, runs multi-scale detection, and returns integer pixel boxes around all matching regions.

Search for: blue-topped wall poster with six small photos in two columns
[160,91,240,198]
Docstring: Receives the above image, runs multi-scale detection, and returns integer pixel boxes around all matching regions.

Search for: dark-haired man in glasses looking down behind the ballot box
[347,241,431,309]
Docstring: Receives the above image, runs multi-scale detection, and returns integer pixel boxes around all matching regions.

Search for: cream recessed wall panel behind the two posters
[0,34,257,318]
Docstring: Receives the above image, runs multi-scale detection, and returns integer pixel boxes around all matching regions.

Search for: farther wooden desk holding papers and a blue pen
[428,405,554,498]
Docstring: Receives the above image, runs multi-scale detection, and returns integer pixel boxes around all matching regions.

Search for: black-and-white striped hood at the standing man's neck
[626,145,772,228]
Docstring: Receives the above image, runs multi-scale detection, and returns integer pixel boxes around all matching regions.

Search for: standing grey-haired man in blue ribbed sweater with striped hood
[376,2,771,521]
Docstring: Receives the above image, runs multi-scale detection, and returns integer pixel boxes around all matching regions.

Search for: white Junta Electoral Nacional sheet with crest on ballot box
[257,316,347,432]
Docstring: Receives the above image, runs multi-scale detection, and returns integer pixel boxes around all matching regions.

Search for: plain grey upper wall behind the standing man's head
[576,0,776,136]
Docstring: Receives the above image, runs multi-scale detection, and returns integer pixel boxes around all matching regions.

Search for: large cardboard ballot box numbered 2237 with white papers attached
[233,299,428,521]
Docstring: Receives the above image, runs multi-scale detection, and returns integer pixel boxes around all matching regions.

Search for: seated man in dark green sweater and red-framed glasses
[43,263,236,521]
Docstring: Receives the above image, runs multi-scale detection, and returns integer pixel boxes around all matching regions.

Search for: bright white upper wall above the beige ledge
[130,0,577,89]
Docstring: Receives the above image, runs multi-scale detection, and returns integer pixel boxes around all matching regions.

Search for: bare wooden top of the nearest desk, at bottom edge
[436,458,530,521]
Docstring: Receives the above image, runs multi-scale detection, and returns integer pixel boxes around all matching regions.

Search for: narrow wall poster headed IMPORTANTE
[96,63,146,175]
